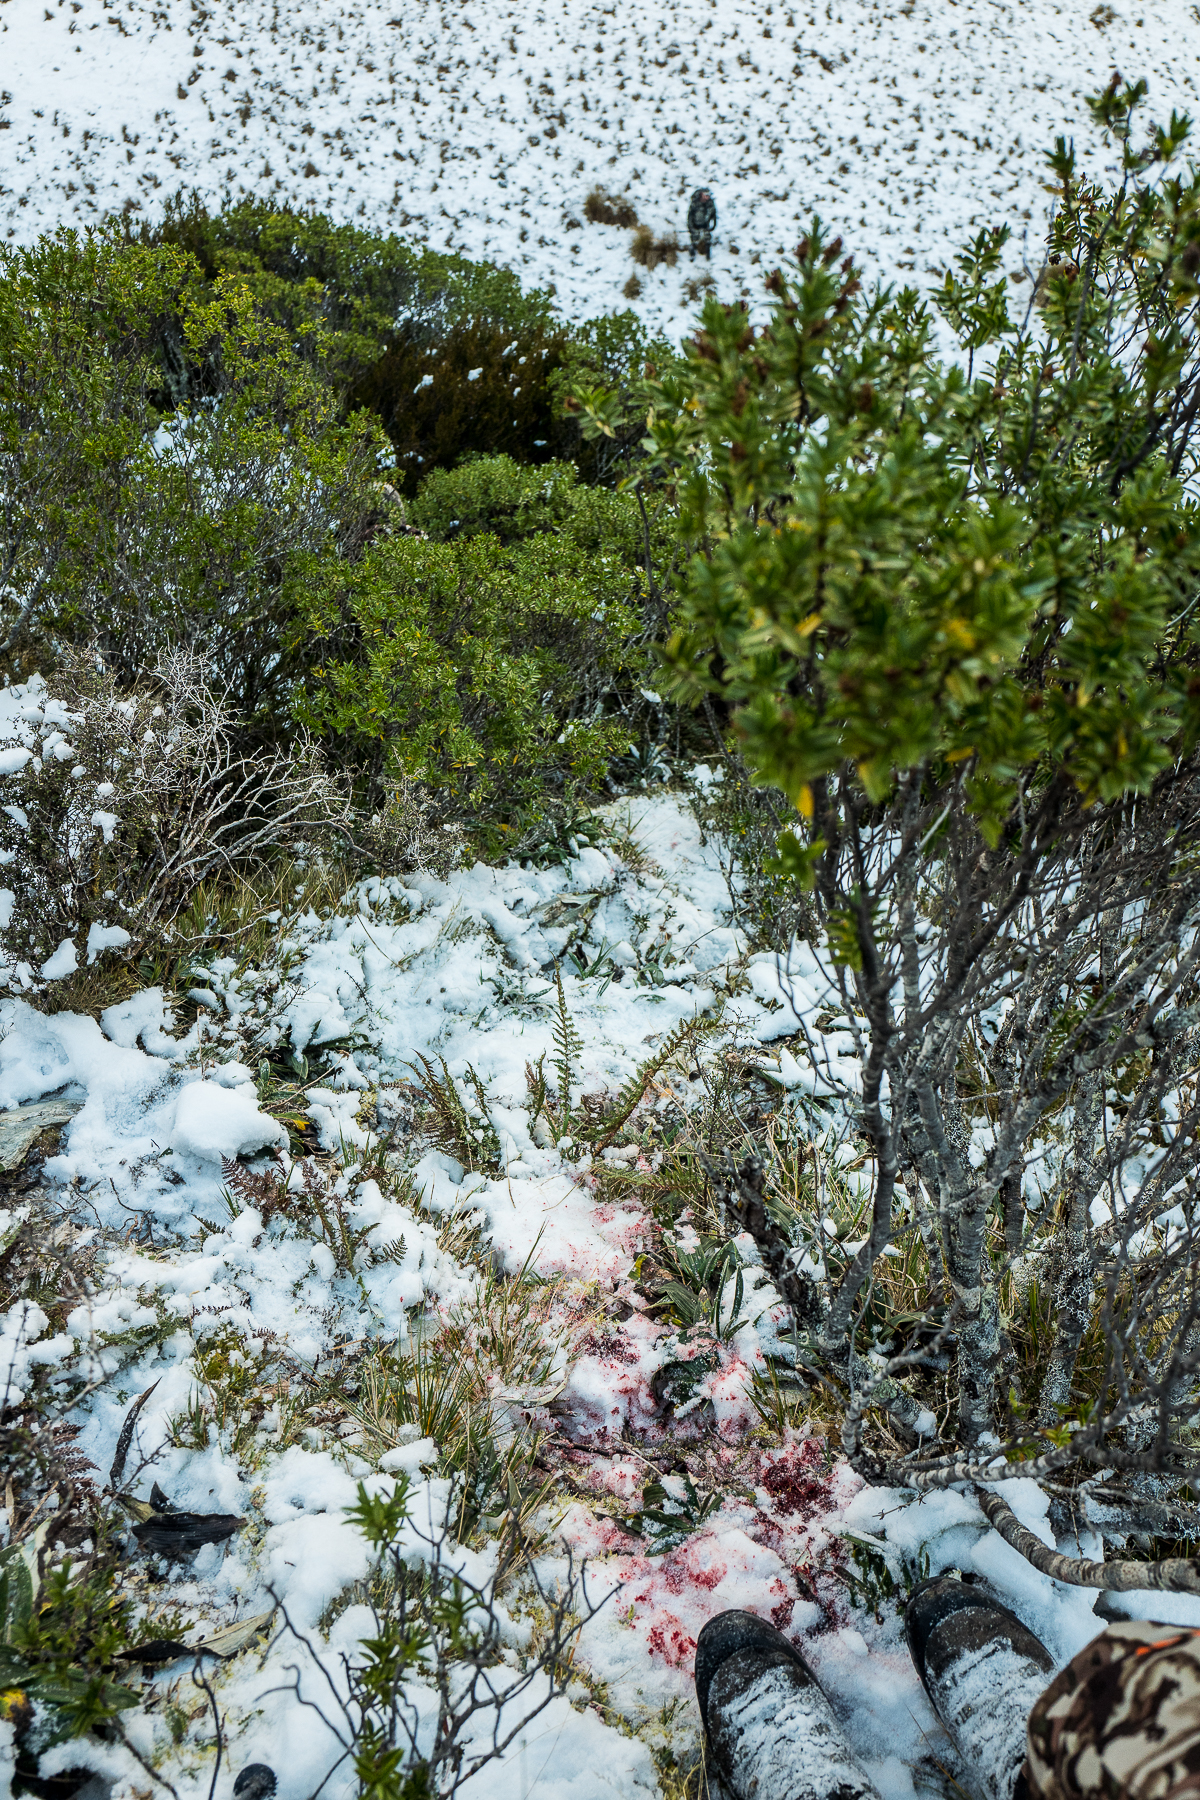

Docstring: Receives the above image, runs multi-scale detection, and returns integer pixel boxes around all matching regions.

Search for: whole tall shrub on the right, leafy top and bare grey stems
[576,77,1200,1591]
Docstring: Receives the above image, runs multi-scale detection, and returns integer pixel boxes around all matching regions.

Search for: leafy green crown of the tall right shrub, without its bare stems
[578,90,1200,860]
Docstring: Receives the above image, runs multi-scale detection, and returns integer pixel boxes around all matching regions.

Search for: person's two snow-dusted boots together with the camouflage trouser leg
[696,1575,1200,1800]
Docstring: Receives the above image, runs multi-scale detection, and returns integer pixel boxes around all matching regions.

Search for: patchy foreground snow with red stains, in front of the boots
[0,772,1193,1800]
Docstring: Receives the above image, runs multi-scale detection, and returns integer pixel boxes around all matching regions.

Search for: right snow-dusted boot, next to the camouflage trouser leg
[905,1575,1054,1800]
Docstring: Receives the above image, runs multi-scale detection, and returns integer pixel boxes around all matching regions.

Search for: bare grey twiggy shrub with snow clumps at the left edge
[0,652,349,988]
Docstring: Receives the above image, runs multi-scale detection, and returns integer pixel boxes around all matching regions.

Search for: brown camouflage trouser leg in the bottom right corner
[1025,1620,1200,1800]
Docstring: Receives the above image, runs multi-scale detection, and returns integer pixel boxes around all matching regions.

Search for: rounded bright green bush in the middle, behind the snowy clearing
[293,500,637,819]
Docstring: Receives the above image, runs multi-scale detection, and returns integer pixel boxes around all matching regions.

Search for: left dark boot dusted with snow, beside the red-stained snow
[696,1613,880,1800]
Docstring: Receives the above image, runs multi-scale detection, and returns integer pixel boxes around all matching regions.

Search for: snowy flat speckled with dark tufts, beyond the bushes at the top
[0,0,1200,333]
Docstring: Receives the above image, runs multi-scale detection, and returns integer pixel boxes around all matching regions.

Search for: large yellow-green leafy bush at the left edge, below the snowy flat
[0,230,380,718]
